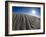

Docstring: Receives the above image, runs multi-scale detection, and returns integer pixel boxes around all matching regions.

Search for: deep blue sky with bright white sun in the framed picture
[12,6,40,16]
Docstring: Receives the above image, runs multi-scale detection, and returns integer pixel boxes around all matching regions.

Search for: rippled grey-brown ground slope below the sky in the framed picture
[12,13,40,30]
